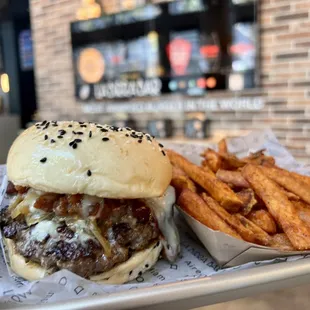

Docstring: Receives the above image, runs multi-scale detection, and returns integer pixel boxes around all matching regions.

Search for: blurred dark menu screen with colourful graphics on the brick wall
[71,0,257,101]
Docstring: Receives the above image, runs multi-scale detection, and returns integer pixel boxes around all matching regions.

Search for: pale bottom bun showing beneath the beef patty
[3,238,162,284]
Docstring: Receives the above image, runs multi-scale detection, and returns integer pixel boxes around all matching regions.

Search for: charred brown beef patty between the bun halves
[0,194,160,278]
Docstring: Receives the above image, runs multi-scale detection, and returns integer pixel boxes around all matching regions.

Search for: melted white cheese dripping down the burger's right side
[145,186,180,261]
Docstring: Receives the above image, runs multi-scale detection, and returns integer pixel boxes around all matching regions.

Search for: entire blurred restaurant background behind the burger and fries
[0,0,310,163]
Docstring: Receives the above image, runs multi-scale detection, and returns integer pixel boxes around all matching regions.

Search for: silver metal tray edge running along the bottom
[19,258,310,310]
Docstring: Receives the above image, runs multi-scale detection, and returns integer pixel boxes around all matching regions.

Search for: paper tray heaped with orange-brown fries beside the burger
[167,130,310,267]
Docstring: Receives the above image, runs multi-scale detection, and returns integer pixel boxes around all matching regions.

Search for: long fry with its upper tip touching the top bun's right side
[167,150,243,212]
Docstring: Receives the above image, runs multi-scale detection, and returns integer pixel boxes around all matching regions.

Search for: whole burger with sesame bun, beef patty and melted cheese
[0,121,180,283]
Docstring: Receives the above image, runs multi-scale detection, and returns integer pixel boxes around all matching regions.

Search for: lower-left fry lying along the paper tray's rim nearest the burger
[177,189,241,239]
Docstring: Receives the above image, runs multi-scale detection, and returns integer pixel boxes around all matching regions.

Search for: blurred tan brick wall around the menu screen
[30,0,310,162]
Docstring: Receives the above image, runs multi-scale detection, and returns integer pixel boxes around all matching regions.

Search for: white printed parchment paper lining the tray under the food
[0,131,310,308]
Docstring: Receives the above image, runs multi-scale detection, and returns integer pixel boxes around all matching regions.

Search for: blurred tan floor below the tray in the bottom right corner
[195,279,310,310]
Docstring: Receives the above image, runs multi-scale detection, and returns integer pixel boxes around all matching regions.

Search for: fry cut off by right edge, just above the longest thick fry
[260,167,310,204]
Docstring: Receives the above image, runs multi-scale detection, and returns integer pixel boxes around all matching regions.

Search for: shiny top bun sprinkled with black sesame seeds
[7,121,172,199]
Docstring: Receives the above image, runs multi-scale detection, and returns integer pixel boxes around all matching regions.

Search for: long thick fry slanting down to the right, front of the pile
[242,164,310,250]
